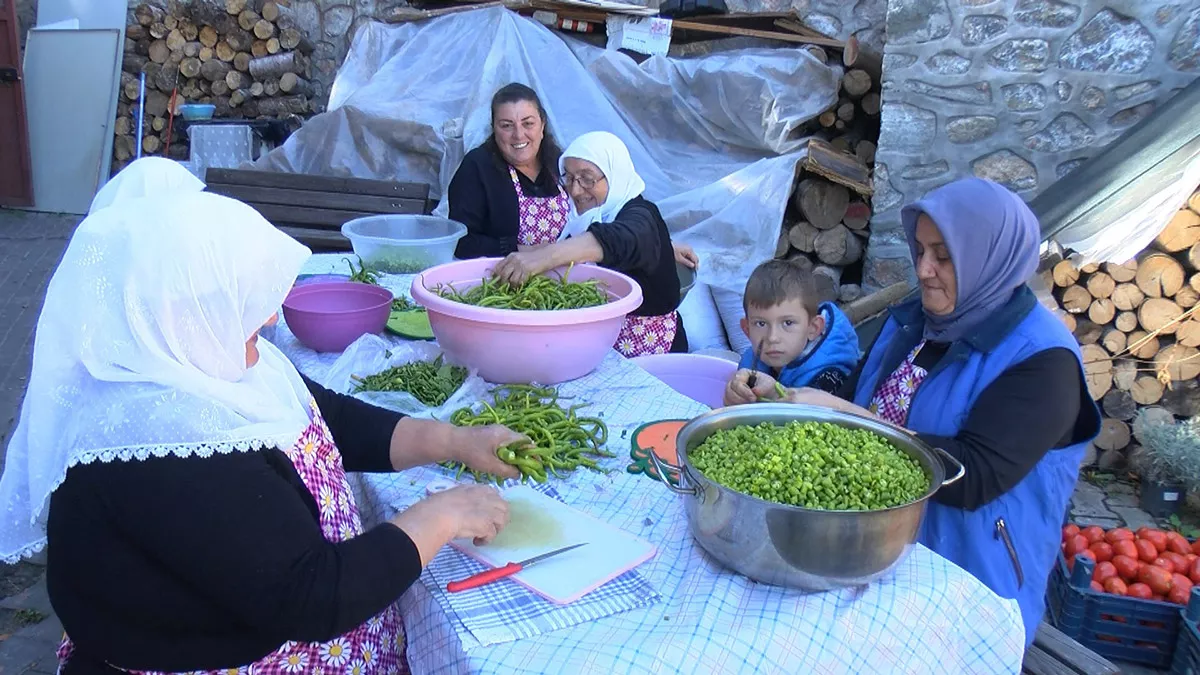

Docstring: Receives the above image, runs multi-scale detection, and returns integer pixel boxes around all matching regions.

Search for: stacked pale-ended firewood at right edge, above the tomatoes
[1048,184,1200,468]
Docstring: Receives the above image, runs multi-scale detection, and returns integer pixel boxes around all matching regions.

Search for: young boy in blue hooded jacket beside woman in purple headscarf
[725,261,858,405]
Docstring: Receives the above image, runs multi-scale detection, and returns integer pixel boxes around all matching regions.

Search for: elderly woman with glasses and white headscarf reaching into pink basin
[496,131,688,357]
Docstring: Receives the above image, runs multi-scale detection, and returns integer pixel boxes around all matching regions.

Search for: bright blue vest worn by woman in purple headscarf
[854,286,1099,646]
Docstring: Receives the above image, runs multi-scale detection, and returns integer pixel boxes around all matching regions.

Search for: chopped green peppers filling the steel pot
[688,422,929,510]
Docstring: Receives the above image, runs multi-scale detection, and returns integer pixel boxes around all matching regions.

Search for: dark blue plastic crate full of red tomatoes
[1046,525,1200,668]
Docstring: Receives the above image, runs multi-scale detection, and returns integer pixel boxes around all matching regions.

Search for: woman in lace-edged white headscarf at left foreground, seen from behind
[0,186,521,675]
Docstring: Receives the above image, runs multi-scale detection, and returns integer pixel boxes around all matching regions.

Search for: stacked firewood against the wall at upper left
[113,0,322,172]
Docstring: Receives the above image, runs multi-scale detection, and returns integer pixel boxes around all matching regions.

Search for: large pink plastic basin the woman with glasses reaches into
[412,258,642,384]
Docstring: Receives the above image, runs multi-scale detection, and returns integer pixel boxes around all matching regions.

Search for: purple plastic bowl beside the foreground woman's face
[283,281,392,352]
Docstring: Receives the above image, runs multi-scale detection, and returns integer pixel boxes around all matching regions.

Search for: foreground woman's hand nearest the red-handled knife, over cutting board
[390,485,509,567]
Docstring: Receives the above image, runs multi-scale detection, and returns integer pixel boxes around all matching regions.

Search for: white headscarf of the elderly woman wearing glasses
[558,131,646,240]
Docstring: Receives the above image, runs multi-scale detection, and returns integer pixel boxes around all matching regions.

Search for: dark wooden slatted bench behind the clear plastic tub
[205,168,432,251]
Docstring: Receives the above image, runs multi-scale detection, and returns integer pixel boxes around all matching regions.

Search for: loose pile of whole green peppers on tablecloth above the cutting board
[443,384,617,483]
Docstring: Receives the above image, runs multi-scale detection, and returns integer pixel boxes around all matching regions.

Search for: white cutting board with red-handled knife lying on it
[428,484,656,604]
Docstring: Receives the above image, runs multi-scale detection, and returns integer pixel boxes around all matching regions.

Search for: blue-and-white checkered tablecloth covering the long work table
[267,253,1024,675]
